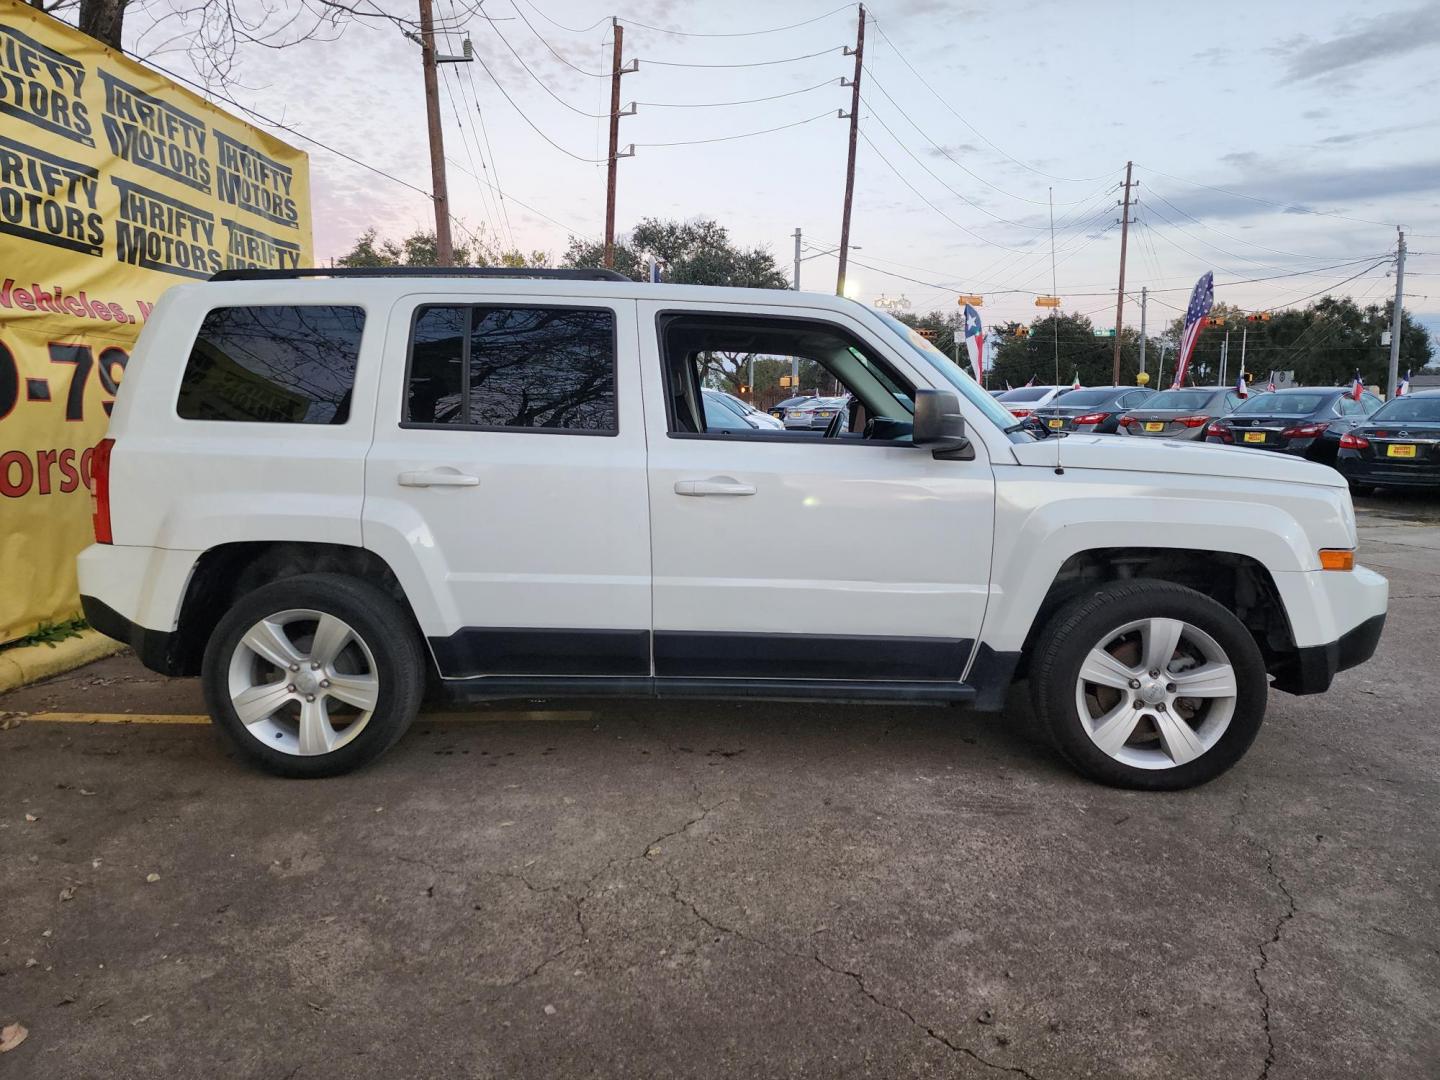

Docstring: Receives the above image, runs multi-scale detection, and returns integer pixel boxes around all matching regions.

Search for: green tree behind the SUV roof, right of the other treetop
[562,217,791,289]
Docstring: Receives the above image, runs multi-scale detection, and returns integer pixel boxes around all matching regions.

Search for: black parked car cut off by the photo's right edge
[1335,390,1440,494]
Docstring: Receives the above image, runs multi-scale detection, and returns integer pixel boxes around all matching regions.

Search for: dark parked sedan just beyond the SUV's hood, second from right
[1205,386,1380,465]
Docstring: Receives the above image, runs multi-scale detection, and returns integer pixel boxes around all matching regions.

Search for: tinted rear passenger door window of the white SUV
[405,307,618,432]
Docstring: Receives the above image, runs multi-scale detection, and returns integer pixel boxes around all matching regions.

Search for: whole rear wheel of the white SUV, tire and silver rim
[202,573,425,778]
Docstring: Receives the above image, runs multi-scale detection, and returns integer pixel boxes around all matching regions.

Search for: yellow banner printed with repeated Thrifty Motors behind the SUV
[0,0,312,642]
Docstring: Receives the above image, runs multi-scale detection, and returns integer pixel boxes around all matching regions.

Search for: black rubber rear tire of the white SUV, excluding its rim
[202,573,426,779]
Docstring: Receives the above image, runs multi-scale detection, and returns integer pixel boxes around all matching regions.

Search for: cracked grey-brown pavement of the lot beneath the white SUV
[0,495,1440,1080]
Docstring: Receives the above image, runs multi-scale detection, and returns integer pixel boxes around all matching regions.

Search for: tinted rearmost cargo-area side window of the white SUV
[176,305,364,423]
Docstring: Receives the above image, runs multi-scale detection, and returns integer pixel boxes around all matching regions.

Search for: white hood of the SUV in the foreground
[1014,435,1345,488]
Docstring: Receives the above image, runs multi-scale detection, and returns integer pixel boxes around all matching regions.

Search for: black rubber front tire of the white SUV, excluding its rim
[1030,579,1269,791]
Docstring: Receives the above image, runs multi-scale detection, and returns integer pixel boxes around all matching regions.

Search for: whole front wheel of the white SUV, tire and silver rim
[1031,580,1269,791]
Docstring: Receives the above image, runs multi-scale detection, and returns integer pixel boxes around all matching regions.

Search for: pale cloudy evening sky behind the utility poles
[112,0,1440,351]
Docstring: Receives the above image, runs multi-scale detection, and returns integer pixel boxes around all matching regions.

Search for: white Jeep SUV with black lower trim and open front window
[79,271,1387,789]
